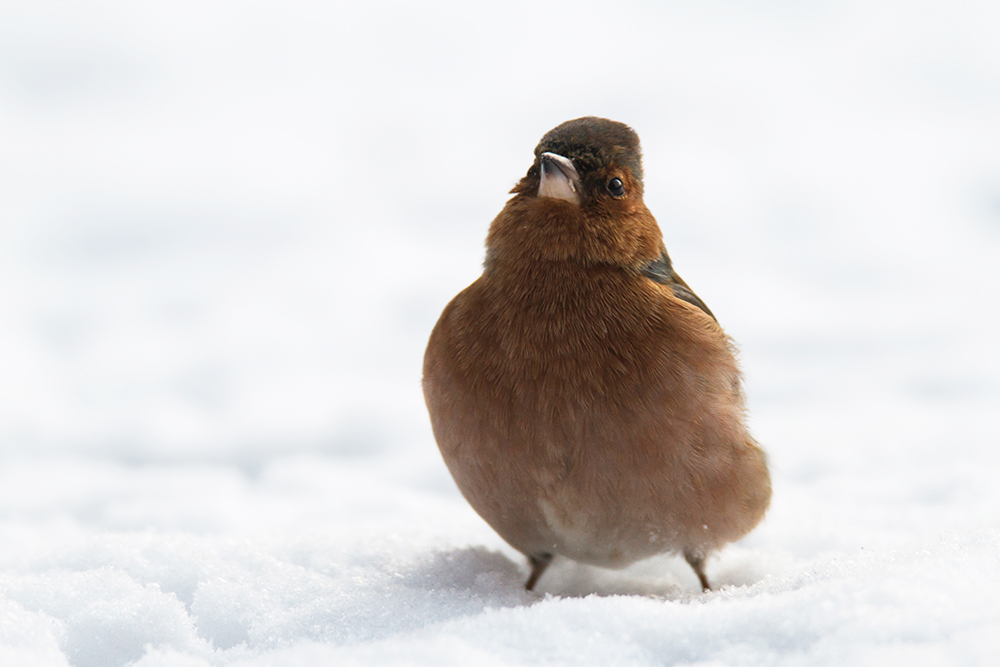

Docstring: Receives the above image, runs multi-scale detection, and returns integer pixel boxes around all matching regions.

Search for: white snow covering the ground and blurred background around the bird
[0,0,1000,667]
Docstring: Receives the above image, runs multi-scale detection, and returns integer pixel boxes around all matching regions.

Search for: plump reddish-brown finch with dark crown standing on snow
[422,116,771,591]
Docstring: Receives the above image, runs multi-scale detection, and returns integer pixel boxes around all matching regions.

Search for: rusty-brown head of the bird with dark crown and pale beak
[487,116,662,266]
